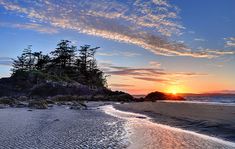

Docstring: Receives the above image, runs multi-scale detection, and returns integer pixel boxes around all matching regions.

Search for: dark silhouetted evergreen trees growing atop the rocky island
[12,40,107,87]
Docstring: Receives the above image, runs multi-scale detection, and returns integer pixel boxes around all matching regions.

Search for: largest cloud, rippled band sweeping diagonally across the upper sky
[0,0,234,58]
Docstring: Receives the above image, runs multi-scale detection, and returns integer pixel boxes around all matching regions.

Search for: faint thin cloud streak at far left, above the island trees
[0,23,59,34]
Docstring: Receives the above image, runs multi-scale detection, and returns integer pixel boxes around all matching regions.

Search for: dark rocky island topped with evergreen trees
[0,40,133,109]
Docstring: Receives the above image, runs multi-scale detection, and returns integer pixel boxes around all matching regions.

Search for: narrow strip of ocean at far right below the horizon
[183,94,235,104]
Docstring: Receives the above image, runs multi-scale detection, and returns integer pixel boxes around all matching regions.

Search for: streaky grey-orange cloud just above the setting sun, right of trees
[100,62,208,85]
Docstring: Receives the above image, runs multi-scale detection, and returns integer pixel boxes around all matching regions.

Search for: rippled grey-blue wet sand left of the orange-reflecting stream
[0,106,128,149]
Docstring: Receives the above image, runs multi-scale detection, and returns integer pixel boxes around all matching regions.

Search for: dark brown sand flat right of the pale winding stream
[113,102,235,142]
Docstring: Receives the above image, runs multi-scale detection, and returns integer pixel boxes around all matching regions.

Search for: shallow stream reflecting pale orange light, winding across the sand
[103,106,235,149]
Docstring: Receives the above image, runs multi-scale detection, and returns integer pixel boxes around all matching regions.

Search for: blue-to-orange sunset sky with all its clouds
[0,0,235,94]
